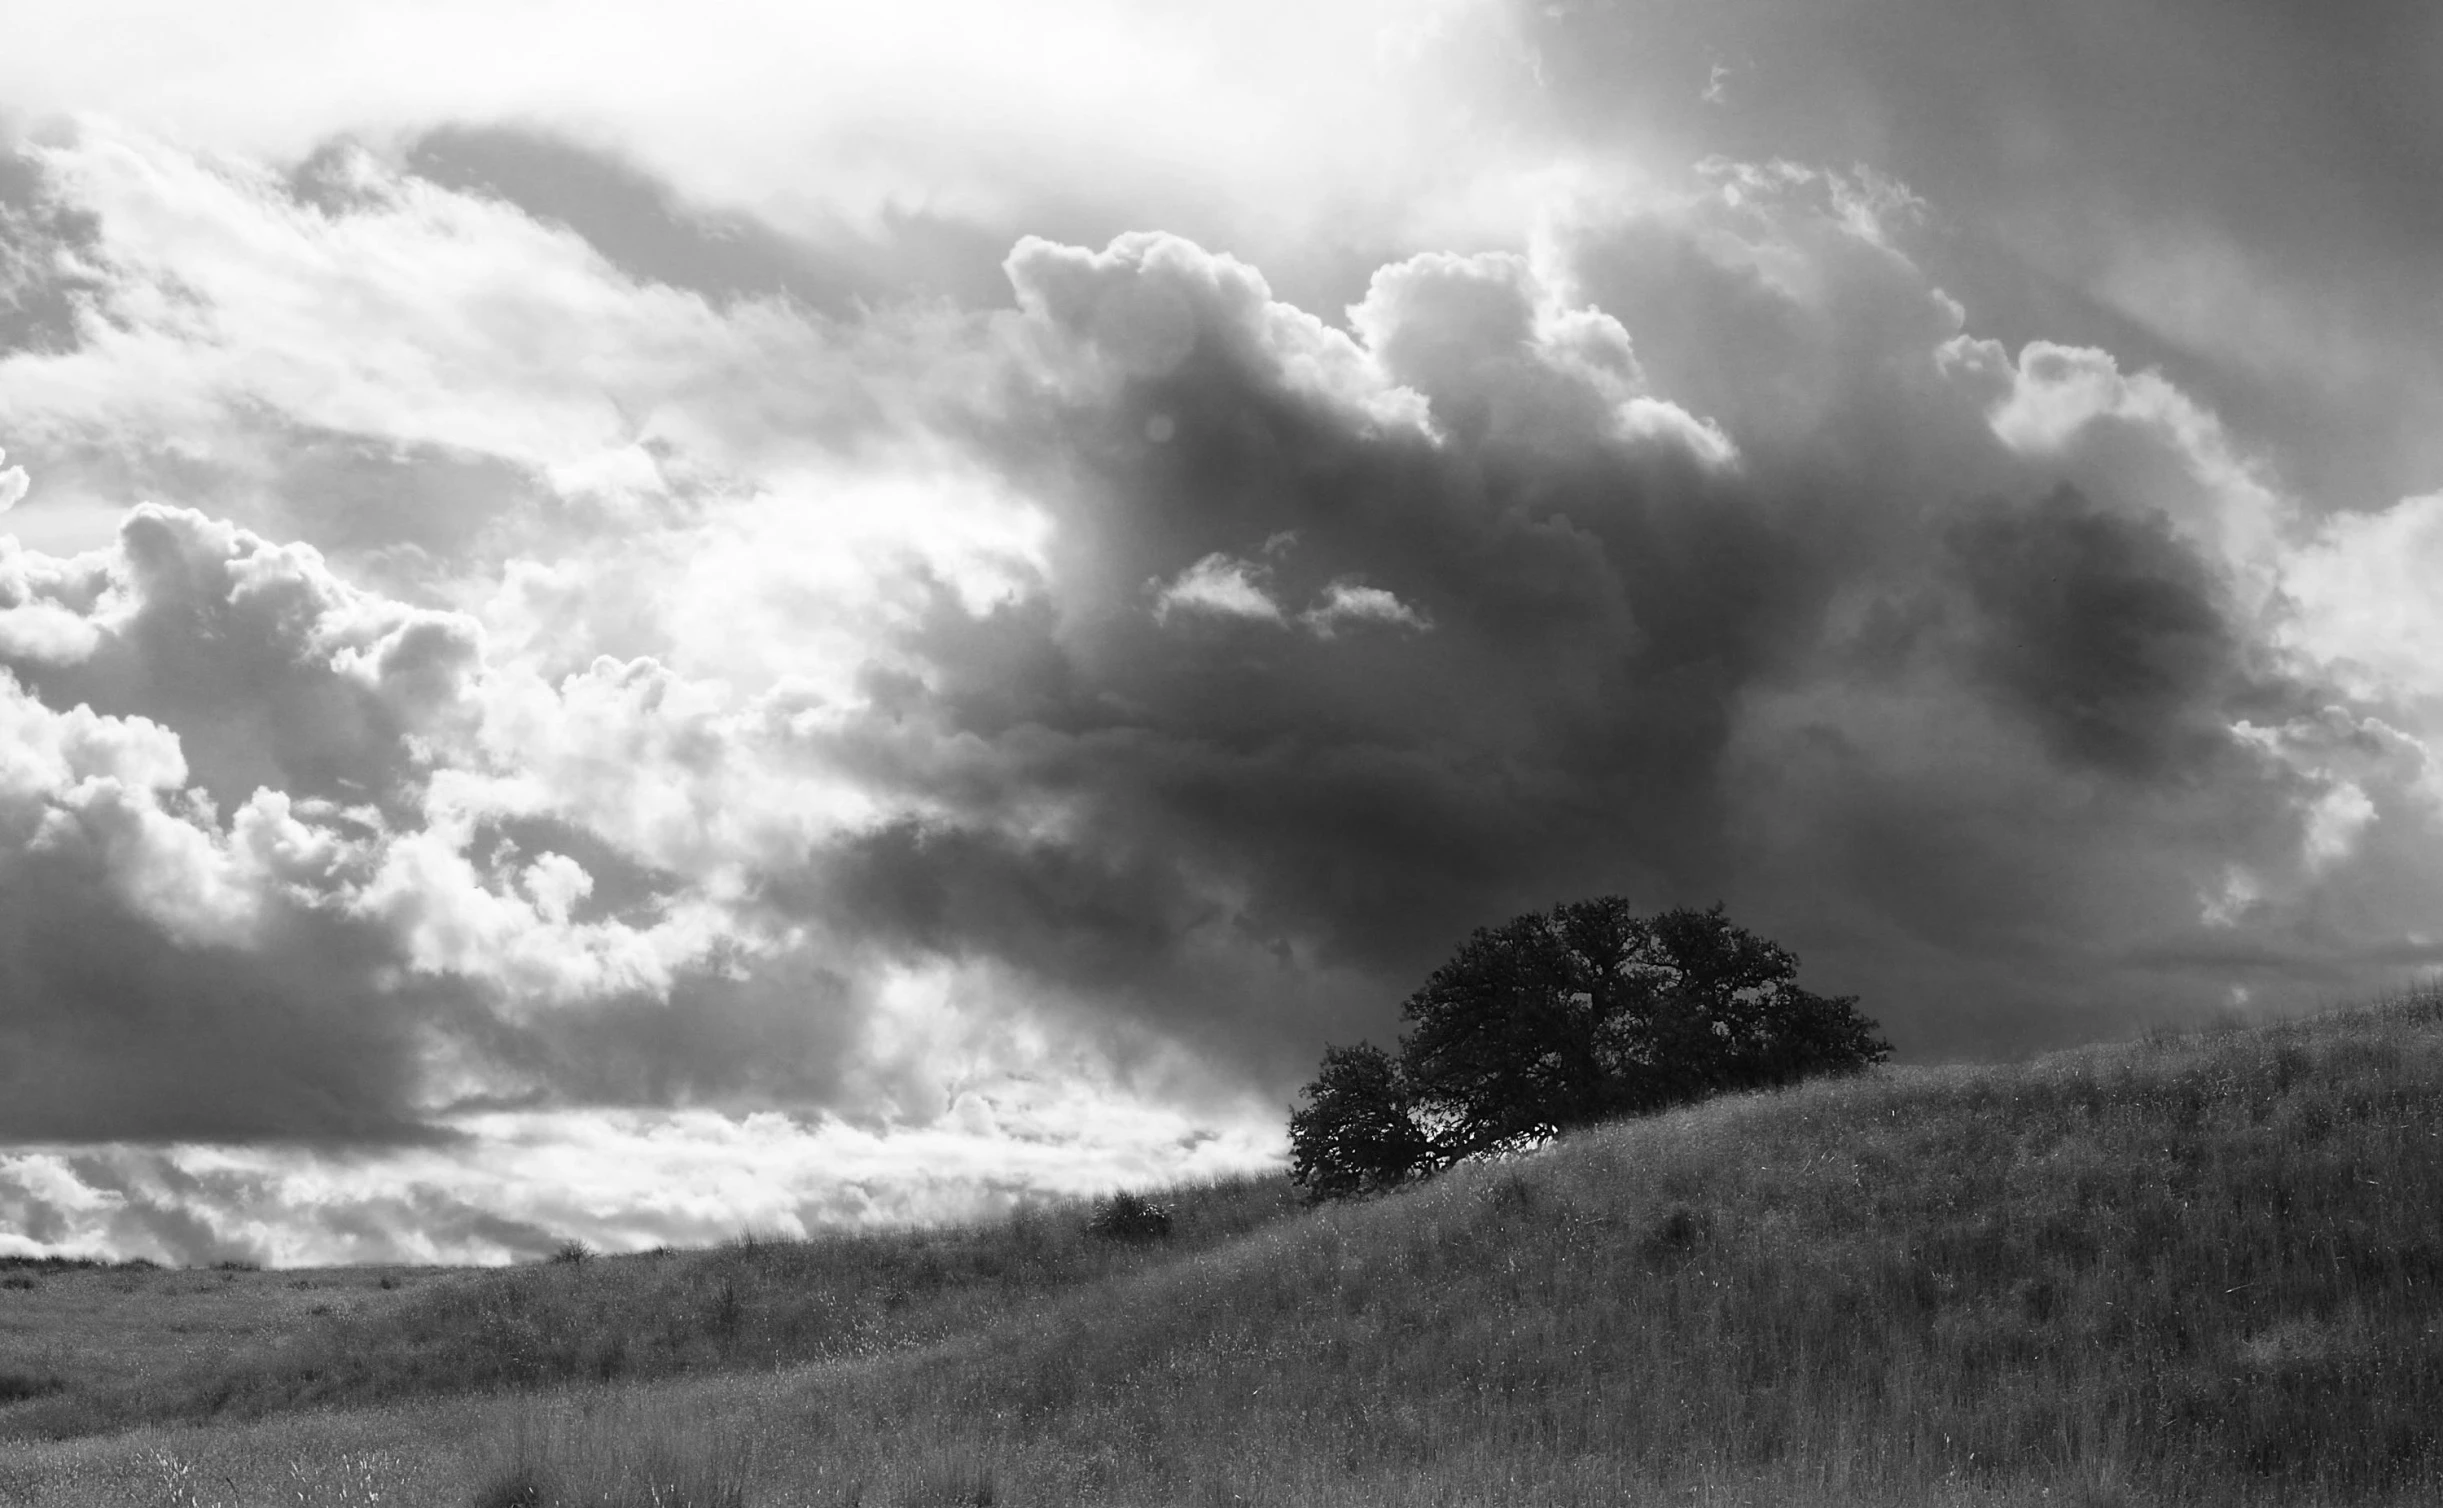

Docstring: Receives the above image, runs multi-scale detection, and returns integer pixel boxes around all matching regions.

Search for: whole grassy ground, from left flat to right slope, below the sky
[0,997,2443,1508]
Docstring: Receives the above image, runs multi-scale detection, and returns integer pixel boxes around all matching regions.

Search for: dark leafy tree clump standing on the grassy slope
[1290,897,1891,1200]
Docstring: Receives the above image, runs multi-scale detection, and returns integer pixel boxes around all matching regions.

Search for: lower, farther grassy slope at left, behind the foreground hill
[0,1176,1300,1440]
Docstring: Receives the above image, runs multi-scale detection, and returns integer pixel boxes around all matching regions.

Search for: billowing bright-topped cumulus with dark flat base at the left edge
[0,506,903,1141]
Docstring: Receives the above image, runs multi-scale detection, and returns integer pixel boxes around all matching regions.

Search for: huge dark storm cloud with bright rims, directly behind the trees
[771,196,2397,1073]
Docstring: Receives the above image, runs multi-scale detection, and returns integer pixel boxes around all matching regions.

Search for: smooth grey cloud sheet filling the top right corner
[1517,0,2443,506]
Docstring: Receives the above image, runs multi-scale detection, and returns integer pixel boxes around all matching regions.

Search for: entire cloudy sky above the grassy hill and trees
[0,0,2443,1264]
